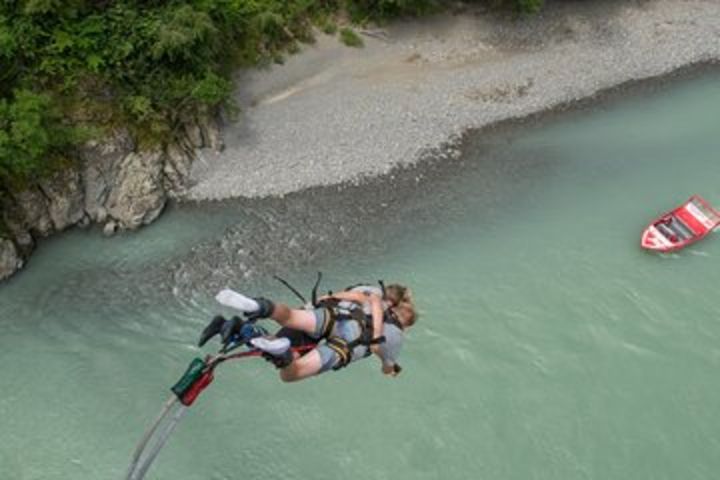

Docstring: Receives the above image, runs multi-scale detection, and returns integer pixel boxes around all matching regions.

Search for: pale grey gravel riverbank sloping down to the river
[187,0,720,200]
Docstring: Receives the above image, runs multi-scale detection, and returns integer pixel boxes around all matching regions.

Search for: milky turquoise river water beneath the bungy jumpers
[0,74,720,480]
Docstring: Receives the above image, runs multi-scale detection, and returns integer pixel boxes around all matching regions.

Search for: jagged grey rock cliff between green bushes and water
[0,118,223,280]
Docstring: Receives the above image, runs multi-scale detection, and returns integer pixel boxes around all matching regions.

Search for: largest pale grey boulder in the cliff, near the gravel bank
[105,150,167,230]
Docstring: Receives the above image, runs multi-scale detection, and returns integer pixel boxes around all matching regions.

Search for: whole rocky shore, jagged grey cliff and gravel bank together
[0,0,720,280]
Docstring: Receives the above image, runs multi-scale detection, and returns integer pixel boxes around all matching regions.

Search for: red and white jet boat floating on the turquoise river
[640,195,720,252]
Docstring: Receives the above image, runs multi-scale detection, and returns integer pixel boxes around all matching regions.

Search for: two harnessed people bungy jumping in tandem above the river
[199,285,417,382]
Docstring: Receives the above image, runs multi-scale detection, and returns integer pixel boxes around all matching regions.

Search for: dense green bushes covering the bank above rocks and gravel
[0,0,542,191]
